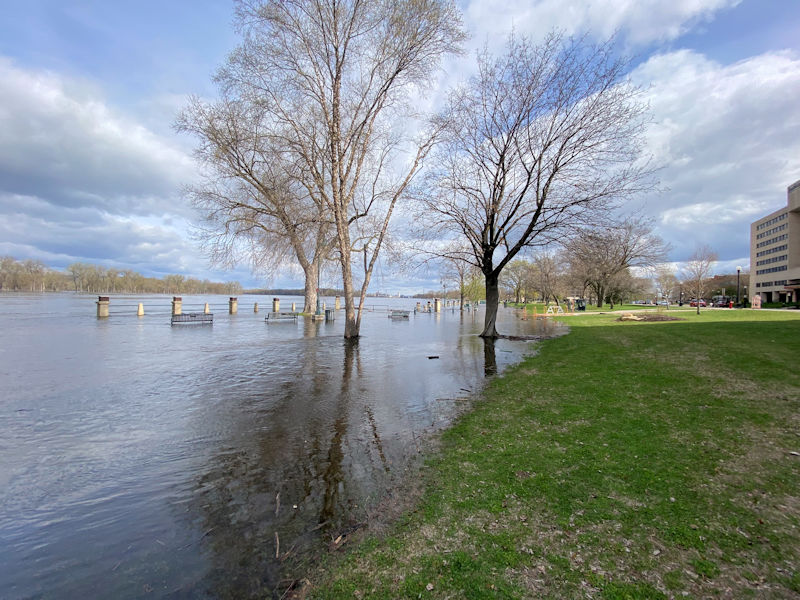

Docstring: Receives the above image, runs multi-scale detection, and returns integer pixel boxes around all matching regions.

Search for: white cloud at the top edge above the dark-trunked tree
[465,0,741,46]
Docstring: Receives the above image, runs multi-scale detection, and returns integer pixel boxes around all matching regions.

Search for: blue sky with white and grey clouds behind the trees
[0,0,800,293]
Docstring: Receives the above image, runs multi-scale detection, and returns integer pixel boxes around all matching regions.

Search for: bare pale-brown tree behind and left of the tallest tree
[176,97,333,312]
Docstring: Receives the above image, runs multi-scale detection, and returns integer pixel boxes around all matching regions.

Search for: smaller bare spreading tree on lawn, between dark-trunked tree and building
[566,217,668,307]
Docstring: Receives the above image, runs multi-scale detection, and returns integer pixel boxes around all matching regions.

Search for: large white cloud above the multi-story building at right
[632,50,800,260]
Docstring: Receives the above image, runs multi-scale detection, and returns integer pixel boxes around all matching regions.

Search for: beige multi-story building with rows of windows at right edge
[748,181,800,302]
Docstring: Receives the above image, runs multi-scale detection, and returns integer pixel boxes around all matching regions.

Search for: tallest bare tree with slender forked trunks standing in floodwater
[218,0,464,338]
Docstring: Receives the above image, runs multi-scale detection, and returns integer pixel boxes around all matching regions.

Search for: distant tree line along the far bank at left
[0,256,243,294]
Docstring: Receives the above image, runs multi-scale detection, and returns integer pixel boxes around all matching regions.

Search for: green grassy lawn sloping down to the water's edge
[305,311,800,599]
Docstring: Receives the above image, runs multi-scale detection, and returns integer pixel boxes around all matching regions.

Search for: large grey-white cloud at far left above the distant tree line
[0,58,194,214]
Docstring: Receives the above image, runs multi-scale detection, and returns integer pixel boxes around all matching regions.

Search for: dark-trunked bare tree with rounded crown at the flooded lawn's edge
[421,34,652,337]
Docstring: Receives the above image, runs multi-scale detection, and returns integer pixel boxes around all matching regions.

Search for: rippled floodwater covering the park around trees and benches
[0,294,564,598]
